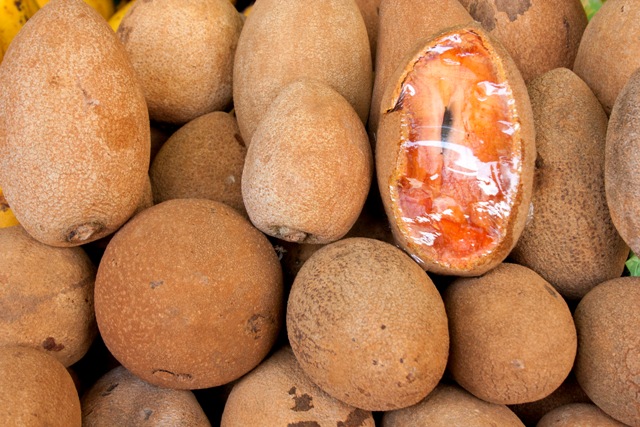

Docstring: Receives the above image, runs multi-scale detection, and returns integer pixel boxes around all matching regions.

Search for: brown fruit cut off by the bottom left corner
[0,346,82,427]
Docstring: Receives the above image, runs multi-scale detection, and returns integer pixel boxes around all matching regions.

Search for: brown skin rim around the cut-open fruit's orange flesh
[375,24,536,276]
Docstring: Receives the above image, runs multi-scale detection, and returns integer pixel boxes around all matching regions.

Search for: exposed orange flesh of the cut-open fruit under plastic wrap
[391,31,521,268]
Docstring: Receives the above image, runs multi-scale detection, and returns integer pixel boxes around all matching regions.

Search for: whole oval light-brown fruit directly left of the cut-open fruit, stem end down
[242,80,373,243]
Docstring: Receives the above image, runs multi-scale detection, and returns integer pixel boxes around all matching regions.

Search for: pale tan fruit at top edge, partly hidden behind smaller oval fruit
[233,0,373,144]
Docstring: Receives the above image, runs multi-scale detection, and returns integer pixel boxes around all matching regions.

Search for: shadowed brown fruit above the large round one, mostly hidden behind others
[150,111,247,216]
